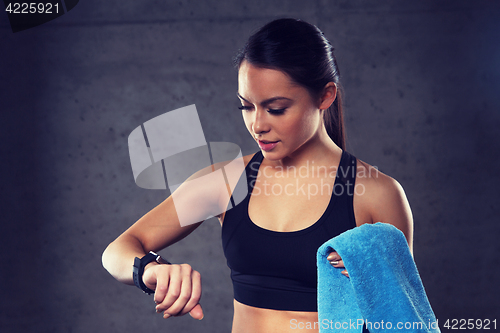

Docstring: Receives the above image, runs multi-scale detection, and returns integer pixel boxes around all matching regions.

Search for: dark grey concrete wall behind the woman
[0,0,500,333]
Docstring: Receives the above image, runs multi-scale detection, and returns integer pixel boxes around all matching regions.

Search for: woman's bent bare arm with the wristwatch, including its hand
[102,161,236,319]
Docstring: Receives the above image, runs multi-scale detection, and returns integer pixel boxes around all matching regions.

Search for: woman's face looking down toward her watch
[238,61,323,160]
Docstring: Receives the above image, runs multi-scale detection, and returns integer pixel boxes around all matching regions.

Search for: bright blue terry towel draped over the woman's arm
[317,223,440,333]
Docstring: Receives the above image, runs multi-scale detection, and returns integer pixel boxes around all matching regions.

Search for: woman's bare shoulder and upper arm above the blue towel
[354,160,413,249]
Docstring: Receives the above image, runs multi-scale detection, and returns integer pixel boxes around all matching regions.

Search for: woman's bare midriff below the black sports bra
[232,300,319,333]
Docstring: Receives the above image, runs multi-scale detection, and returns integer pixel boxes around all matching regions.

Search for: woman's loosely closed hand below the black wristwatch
[142,263,203,320]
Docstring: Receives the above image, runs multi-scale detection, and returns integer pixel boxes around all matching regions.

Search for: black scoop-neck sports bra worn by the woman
[222,151,356,312]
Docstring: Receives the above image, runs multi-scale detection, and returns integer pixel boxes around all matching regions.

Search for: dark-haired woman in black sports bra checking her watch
[103,19,413,333]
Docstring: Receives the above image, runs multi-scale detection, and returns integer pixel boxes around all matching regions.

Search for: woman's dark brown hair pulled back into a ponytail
[235,18,345,150]
